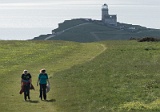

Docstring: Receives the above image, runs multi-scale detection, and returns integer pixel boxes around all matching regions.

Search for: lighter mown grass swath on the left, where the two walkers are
[0,41,104,112]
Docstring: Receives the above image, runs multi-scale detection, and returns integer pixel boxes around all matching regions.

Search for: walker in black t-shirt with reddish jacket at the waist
[21,70,32,101]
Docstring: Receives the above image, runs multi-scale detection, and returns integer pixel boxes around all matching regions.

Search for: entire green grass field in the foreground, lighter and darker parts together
[0,41,160,112]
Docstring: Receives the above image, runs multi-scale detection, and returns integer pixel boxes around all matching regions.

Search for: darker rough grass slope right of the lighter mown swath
[52,41,160,112]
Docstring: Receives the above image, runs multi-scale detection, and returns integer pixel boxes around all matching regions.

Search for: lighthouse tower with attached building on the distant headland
[102,4,117,26]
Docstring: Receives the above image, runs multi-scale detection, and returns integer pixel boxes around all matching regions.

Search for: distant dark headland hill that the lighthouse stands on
[33,19,160,42]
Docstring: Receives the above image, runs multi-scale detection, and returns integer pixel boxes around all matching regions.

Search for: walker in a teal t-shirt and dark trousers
[37,69,50,100]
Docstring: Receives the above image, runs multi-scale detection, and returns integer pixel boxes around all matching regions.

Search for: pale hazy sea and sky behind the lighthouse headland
[0,0,160,39]
